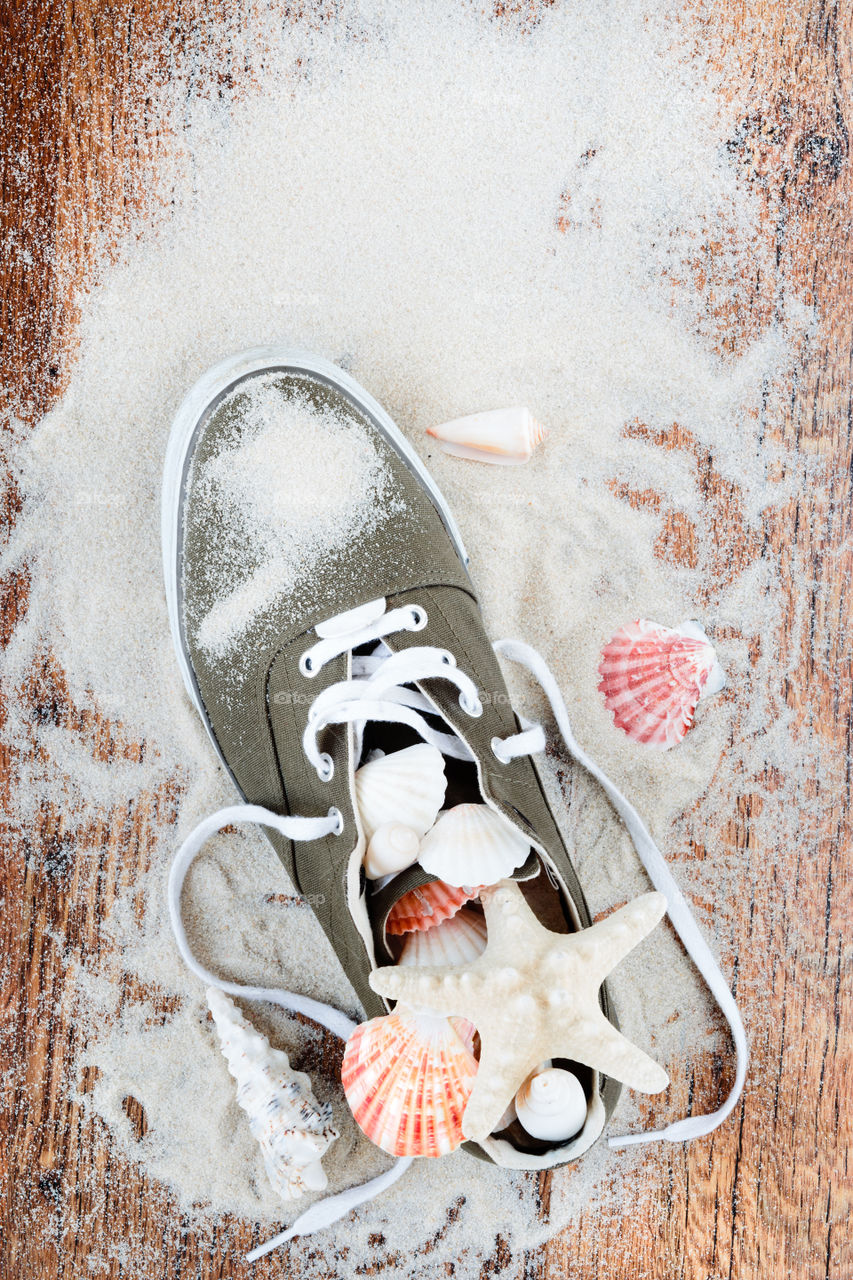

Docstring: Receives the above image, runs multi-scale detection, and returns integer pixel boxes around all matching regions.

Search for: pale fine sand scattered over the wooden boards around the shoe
[4,3,808,1276]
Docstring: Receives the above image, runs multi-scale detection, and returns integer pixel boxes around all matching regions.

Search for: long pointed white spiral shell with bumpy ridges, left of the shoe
[207,987,338,1201]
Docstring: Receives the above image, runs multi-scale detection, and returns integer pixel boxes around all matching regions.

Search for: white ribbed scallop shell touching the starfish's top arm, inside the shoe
[418,804,530,886]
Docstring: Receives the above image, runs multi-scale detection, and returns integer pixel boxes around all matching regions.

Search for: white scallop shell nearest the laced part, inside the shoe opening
[355,742,447,841]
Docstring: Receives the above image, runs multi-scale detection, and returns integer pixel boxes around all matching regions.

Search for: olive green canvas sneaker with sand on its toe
[163,347,742,1169]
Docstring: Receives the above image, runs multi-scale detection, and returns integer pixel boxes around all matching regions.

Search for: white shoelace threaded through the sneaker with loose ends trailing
[168,605,748,1262]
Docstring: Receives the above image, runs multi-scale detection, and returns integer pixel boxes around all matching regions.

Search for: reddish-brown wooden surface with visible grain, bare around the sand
[0,0,853,1280]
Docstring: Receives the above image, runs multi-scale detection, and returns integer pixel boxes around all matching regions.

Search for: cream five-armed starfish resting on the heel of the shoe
[370,879,670,1140]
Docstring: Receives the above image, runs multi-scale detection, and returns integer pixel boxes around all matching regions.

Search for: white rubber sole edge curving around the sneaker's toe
[161,347,467,742]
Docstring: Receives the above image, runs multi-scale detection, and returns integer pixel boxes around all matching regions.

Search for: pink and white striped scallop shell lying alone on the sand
[598,618,725,750]
